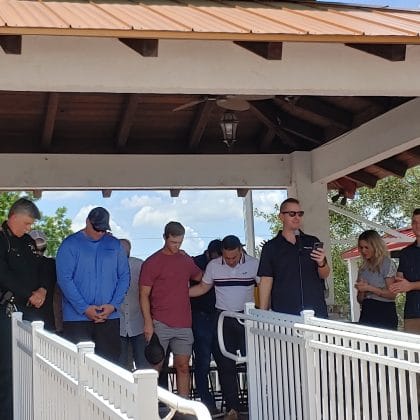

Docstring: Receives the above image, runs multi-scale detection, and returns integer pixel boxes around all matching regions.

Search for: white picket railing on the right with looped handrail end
[218,304,420,420]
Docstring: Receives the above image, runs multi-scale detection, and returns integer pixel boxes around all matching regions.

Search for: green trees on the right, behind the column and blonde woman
[255,166,420,318]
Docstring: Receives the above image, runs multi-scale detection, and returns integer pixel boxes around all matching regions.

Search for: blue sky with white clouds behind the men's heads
[37,190,286,258]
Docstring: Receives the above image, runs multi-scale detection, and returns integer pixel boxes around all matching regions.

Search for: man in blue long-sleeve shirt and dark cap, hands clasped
[56,207,130,362]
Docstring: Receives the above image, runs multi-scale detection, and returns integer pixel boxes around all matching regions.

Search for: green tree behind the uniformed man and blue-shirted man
[0,191,72,256]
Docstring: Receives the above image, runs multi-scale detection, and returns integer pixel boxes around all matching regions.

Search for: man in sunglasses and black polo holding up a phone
[258,198,330,318]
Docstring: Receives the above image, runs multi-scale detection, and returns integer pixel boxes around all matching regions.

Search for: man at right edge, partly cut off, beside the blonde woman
[389,208,420,334]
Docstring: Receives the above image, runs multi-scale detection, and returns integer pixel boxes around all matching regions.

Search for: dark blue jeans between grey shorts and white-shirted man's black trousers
[192,312,217,408]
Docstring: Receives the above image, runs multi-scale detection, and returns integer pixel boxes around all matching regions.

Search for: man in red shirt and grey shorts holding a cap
[140,222,202,398]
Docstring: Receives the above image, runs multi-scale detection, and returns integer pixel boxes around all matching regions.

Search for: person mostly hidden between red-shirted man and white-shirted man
[191,239,222,413]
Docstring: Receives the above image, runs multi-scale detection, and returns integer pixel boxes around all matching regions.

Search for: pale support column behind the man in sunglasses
[288,152,334,304]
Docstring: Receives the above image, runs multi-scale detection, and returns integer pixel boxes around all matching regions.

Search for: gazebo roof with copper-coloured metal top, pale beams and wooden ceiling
[0,0,420,302]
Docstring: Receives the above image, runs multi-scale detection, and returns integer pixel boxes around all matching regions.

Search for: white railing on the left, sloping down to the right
[12,313,211,420]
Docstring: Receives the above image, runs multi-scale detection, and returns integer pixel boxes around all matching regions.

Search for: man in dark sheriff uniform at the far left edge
[0,198,48,420]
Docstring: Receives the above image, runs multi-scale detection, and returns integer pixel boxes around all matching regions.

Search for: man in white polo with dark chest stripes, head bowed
[189,235,259,420]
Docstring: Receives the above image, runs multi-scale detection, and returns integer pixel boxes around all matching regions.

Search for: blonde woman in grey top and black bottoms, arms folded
[355,230,398,329]
